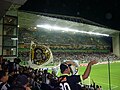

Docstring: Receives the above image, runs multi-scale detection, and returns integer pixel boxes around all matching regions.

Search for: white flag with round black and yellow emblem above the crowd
[28,42,53,69]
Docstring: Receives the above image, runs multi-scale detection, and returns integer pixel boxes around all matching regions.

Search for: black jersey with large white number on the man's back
[59,75,81,90]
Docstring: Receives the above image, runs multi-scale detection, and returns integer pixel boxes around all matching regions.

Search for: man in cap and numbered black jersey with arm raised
[59,60,97,90]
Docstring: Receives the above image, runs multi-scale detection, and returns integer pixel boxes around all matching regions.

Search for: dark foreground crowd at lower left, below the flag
[0,58,57,90]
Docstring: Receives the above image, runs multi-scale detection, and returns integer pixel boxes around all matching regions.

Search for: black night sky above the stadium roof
[19,0,120,30]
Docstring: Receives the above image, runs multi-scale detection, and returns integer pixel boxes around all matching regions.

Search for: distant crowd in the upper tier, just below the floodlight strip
[18,29,110,46]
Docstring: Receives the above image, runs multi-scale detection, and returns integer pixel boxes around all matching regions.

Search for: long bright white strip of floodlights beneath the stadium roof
[37,24,109,37]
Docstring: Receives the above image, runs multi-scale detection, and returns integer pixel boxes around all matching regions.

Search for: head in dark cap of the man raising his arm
[60,63,71,74]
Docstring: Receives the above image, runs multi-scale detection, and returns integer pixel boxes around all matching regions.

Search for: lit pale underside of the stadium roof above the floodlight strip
[18,12,119,36]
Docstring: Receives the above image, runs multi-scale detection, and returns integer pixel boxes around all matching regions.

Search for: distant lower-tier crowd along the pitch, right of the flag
[53,52,120,63]
